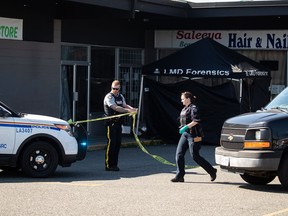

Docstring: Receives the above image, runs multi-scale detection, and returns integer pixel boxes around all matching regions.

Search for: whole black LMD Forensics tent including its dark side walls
[139,38,271,144]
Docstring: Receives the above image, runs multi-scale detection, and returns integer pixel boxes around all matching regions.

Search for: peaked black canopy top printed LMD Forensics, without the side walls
[142,38,270,79]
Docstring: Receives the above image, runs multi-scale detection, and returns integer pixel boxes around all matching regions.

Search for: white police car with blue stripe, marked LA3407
[0,101,87,178]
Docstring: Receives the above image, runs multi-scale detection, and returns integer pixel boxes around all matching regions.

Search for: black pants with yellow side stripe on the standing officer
[105,123,122,168]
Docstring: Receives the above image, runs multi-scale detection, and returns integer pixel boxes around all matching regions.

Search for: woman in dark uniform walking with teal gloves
[171,92,217,182]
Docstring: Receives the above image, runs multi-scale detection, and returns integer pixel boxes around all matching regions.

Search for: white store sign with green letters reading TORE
[0,17,23,40]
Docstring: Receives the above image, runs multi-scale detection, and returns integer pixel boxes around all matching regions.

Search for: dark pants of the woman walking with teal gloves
[176,132,214,177]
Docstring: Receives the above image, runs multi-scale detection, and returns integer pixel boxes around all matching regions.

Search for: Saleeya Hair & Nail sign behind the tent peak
[155,30,288,50]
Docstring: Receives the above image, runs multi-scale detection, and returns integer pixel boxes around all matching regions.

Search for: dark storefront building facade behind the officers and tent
[0,0,288,134]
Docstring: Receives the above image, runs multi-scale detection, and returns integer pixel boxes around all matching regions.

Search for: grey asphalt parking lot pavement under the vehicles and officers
[0,139,288,216]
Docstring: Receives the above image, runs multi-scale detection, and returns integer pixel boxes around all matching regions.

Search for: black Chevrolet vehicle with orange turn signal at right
[215,87,288,188]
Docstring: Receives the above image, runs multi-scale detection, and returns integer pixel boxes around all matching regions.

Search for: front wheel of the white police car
[20,141,58,178]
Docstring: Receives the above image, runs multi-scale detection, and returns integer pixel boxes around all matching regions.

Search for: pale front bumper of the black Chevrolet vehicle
[215,147,282,172]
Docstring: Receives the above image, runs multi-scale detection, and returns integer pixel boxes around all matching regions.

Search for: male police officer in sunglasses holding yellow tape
[104,80,137,171]
